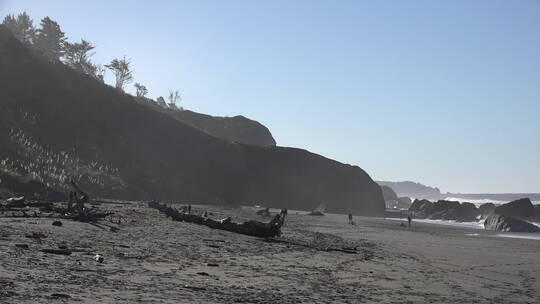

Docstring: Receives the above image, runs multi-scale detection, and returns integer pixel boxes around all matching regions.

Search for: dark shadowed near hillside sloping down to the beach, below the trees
[0,26,385,215]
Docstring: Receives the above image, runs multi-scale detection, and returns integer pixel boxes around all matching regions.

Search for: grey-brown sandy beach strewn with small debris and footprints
[0,203,540,303]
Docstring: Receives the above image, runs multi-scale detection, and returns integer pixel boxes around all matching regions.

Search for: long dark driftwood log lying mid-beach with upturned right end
[148,201,287,238]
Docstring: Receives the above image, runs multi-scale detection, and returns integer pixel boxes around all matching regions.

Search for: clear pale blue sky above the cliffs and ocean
[0,0,540,193]
